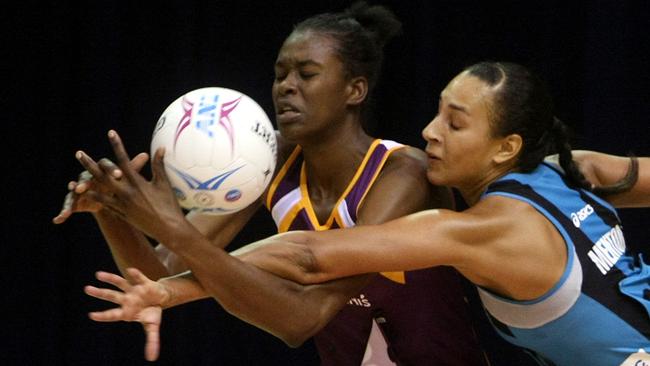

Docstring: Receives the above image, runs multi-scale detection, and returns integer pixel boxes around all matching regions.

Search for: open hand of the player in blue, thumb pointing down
[84,268,170,361]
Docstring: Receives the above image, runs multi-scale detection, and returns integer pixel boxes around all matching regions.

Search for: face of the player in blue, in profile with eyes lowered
[422,72,499,190]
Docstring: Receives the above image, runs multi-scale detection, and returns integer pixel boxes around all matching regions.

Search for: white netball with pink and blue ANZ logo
[151,87,277,214]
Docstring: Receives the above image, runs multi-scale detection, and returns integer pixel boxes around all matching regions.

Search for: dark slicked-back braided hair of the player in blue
[465,62,591,190]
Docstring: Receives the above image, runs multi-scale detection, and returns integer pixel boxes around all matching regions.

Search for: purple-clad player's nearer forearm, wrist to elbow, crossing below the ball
[165,220,342,346]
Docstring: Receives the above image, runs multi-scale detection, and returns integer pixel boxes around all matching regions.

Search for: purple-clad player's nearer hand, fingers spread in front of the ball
[76,130,185,242]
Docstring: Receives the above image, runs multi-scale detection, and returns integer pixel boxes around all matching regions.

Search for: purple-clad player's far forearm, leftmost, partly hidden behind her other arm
[94,211,170,280]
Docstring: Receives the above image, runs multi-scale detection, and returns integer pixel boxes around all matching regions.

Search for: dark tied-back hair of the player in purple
[293,1,402,131]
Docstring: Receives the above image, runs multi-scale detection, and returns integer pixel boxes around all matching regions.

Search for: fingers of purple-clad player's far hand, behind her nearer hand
[52,153,149,224]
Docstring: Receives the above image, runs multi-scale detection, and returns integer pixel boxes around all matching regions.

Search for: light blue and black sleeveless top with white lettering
[479,163,650,366]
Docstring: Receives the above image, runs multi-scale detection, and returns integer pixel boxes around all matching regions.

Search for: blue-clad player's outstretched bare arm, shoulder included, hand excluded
[241,196,566,300]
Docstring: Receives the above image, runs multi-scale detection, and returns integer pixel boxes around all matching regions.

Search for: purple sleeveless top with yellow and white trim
[266,140,485,366]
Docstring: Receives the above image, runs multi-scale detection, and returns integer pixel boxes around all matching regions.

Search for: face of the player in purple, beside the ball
[272,31,348,144]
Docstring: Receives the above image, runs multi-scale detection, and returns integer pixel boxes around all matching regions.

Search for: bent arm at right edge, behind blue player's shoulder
[572,150,650,207]
